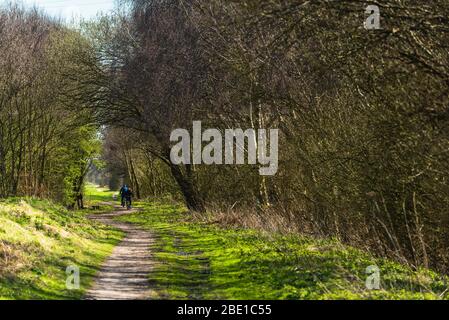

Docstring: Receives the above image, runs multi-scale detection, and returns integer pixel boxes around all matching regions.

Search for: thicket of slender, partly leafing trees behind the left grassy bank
[0,5,101,207]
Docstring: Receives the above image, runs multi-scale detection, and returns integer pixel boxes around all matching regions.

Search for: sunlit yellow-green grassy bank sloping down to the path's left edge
[0,199,123,299]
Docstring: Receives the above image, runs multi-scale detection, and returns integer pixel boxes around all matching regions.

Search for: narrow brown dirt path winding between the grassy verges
[86,207,154,300]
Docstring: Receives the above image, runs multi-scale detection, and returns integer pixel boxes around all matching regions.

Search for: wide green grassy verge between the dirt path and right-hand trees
[120,203,447,299]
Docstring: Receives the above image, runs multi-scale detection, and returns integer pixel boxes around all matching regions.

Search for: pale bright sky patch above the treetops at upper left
[0,0,115,21]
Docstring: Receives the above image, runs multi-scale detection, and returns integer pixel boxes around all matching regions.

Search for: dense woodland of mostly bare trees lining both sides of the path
[0,0,449,272]
